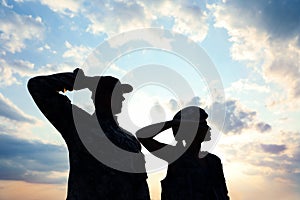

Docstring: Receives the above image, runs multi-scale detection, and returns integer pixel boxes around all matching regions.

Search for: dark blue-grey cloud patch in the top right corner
[226,0,300,44]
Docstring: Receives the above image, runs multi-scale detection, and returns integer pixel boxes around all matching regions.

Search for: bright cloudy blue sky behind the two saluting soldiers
[0,0,300,200]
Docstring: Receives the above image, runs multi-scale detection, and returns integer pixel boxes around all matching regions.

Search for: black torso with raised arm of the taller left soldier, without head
[28,73,150,200]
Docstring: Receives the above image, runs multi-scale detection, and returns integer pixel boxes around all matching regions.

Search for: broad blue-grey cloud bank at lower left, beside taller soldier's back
[0,134,68,183]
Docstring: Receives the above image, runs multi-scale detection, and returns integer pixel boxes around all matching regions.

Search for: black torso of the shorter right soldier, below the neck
[161,153,229,200]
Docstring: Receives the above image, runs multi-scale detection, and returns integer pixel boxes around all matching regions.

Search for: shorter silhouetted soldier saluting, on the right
[137,106,229,200]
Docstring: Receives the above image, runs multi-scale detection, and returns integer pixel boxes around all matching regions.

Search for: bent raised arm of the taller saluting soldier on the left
[27,69,84,139]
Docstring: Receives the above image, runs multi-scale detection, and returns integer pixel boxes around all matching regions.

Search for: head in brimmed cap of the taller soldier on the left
[92,76,133,115]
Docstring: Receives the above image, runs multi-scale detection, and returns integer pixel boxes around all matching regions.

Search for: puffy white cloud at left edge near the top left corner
[0,7,44,54]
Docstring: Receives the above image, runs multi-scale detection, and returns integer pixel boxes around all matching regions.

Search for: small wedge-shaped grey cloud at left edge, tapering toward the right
[0,93,36,123]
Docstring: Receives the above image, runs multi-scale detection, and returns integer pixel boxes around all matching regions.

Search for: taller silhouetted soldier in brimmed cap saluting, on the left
[28,69,150,200]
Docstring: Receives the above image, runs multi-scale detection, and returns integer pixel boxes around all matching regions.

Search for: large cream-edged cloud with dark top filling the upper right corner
[209,0,300,104]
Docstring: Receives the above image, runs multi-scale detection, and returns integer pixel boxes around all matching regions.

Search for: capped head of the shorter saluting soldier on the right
[172,106,211,148]
